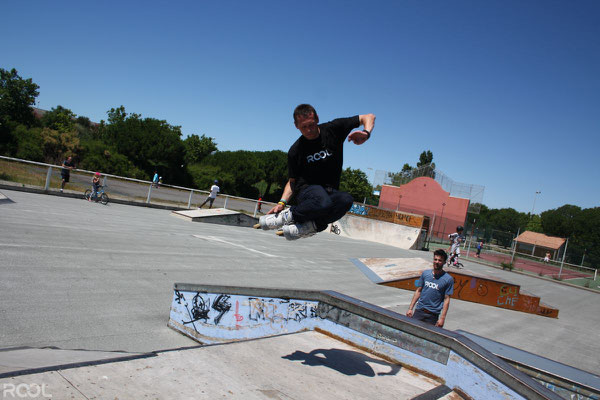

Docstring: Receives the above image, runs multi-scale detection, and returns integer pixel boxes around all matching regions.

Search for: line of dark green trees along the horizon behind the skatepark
[0,68,600,265]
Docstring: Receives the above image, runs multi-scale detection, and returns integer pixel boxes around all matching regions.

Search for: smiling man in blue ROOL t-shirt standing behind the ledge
[406,249,454,328]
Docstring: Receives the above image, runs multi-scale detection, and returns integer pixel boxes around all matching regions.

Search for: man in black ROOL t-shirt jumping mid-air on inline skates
[255,104,375,240]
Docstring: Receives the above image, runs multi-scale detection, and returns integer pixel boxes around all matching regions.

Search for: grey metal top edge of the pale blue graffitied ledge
[173,283,562,400]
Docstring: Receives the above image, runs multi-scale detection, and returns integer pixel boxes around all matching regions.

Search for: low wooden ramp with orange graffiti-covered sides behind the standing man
[352,258,558,318]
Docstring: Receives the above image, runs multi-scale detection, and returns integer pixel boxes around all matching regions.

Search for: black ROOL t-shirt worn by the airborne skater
[288,115,360,194]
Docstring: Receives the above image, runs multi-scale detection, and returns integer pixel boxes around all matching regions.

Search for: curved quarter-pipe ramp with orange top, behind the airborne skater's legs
[329,203,428,249]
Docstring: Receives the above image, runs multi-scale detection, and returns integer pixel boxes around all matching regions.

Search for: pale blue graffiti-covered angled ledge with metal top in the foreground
[168,283,560,400]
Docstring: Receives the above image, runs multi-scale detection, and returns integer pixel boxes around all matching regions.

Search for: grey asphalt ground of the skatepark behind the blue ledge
[0,189,600,380]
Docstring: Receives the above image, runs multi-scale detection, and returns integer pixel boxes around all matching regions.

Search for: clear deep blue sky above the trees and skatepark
[0,0,600,213]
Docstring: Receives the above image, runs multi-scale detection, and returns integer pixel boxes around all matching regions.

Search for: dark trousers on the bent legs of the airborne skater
[292,185,353,232]
